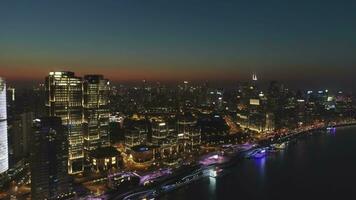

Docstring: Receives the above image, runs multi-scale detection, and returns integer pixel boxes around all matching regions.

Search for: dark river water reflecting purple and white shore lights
[161,126,356,200]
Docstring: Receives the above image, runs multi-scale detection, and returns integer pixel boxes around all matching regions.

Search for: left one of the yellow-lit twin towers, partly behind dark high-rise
[45,72,84,174]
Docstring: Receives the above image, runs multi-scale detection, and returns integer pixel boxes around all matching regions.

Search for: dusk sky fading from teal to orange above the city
[0,0,356,88]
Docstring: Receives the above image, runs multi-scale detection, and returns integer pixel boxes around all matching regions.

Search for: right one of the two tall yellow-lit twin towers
[83,75,110,154]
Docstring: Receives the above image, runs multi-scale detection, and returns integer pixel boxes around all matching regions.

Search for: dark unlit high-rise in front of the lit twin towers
[30,117,73,200]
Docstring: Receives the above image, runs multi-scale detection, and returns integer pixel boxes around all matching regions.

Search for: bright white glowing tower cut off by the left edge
[0,78,9,174]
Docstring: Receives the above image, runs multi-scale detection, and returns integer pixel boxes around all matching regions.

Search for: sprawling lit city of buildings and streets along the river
[0,71,356,200]
